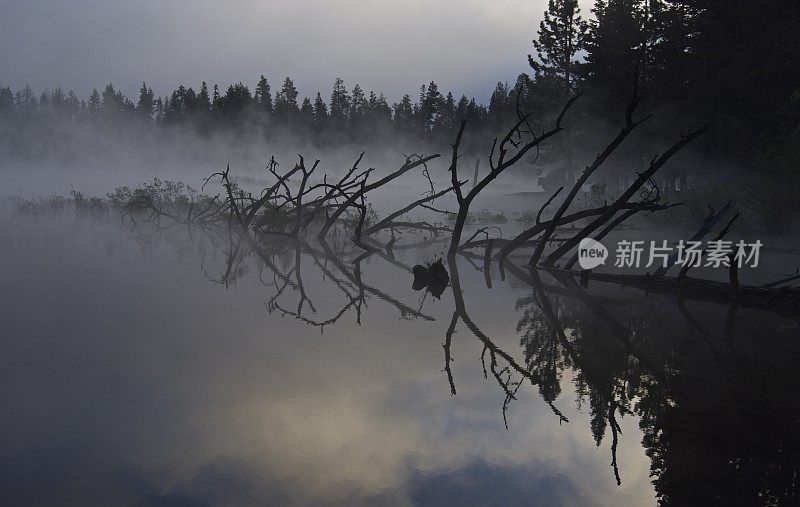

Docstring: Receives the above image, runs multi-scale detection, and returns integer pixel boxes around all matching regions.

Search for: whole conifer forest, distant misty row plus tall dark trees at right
[0,0,800,169]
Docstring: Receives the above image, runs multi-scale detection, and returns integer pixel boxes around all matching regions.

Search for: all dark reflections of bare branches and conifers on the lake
[122,220,800,505]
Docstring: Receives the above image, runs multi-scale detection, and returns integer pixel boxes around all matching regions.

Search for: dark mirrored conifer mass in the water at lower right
[509,260,800,505]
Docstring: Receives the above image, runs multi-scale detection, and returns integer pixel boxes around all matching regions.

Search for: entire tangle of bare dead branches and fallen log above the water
[31,75,800,324]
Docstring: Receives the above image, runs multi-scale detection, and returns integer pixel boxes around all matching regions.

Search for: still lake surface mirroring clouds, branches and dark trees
[0,204,800,506]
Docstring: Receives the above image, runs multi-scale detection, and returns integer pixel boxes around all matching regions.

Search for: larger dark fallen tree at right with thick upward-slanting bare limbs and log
[438,83,800,312]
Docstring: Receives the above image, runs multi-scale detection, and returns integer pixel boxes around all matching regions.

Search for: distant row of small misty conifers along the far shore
[0,75,494,143]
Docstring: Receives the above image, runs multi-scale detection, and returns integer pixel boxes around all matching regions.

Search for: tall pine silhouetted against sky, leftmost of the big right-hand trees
[528,0,589,95]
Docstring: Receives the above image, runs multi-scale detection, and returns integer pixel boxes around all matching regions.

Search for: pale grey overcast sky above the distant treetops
[0,0,588,102]
